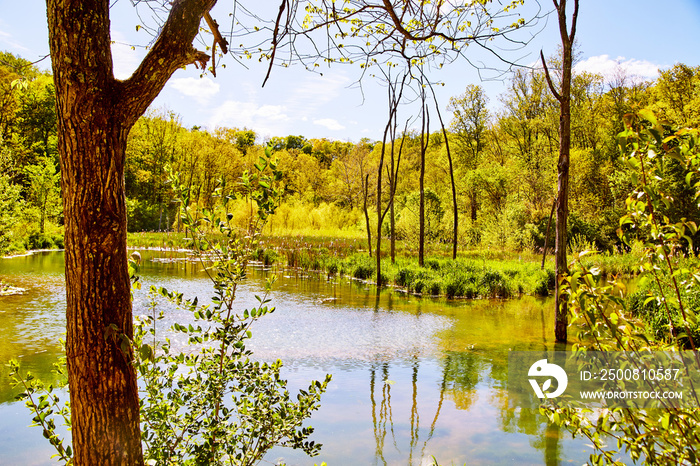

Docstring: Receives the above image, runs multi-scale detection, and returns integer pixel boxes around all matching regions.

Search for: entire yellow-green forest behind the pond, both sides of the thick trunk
[0,52,700,260]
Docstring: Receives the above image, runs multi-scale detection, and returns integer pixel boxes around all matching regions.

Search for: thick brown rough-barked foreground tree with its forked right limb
[47,0,216,465]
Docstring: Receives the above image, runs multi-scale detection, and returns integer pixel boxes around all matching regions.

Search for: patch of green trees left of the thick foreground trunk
[0,52,63,253]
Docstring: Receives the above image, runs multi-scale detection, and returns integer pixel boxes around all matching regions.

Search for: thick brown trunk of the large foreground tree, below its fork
[64,124,143,465]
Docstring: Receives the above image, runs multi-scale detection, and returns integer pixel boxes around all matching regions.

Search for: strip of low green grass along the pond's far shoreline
[0,232,660,299]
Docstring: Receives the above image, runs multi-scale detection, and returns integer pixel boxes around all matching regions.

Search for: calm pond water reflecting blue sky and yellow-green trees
[0,251,600,465]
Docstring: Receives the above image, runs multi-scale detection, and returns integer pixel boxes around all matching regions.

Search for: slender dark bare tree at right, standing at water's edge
[540,0,579,342]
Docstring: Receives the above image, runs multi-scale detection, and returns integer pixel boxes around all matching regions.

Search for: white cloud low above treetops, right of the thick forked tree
[208,100,291,137]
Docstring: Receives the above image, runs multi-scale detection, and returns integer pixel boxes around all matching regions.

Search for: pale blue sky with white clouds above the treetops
[0,0,700,142]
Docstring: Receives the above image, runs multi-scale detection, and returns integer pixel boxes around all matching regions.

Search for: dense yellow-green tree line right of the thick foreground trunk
[120,64,700,256]
